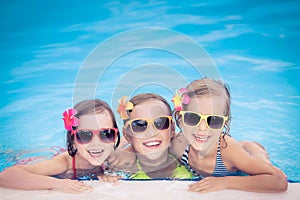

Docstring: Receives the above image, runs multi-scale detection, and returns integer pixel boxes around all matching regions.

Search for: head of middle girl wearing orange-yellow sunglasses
[118,93,175,164]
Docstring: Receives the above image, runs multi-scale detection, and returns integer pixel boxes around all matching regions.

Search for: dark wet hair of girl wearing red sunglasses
[67,99,120,157]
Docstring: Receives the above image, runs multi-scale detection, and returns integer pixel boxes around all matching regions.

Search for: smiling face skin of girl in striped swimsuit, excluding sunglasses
[180,96,225,156]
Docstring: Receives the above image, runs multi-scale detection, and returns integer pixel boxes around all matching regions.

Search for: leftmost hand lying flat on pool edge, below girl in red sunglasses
[53,179,93,194]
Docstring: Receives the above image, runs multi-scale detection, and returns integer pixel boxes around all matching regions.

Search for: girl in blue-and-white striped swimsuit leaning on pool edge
[173,78,287,193]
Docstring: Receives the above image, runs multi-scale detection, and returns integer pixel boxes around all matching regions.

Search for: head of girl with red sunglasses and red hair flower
[63,99,120,166]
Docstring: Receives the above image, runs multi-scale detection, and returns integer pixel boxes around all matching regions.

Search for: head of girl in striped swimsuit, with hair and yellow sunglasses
[173,78,231,157]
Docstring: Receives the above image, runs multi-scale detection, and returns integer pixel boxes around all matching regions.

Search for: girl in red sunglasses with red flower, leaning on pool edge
[0,99,120,193]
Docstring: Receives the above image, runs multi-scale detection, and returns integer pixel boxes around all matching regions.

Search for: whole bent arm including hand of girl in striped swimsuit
[189,137,288,192]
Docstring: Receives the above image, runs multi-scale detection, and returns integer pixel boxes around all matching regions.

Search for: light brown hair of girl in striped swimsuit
[174,78,231,135]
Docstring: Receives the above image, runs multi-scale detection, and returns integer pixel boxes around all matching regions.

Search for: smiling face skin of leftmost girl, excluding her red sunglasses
[75,110,114,166]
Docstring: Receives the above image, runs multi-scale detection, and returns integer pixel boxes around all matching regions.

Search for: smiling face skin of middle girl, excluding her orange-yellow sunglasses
[125,100,172,160]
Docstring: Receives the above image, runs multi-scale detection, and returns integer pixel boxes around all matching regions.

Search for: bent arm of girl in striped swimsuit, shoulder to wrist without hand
[224,137,287,192]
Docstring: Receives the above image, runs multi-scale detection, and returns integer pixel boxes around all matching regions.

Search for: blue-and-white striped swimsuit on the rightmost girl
[180,139,245,179]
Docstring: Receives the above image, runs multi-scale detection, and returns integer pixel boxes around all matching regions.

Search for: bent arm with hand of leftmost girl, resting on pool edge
[0,154,90,193]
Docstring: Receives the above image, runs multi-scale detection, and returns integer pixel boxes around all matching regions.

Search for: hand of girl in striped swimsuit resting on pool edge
[188,177,227,193]
